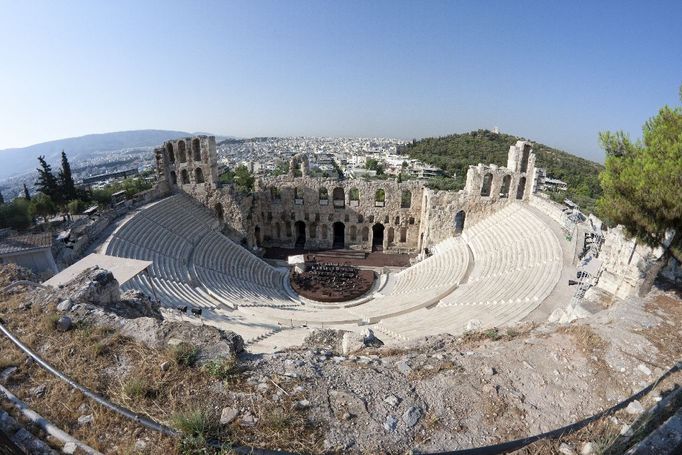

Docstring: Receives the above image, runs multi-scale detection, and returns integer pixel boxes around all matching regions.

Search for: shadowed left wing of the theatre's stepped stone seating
[106,194,297,309]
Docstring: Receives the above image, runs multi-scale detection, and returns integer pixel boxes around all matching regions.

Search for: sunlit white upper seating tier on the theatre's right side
[377,204,562,339]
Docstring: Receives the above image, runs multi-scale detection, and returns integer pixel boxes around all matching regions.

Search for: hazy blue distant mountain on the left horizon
[0,130,197,178]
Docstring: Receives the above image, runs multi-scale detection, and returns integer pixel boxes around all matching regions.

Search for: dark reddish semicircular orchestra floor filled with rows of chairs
[289,262,374,303]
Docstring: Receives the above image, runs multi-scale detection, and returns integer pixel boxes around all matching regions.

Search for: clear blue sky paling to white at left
[0,0,682,160]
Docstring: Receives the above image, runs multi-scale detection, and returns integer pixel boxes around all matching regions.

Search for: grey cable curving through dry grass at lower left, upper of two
[0,323,287,455]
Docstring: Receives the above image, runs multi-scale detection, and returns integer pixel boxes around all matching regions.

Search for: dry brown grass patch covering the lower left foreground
[0,290,322,454]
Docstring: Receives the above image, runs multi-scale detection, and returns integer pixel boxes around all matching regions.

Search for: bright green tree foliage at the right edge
[598,93,682,259]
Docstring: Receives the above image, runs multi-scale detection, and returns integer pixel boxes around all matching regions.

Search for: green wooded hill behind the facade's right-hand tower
[401,130,604,212]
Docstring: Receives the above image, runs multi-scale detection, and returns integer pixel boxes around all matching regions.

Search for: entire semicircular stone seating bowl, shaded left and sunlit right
[106,194,562,340]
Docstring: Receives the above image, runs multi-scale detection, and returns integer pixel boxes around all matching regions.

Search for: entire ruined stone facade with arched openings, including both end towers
[156,136,535,253]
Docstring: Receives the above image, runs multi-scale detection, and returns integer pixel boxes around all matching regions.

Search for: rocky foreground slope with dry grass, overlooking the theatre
[0,269,682,453]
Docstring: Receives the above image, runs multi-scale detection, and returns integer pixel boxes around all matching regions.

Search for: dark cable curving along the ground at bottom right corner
[431,361,682,455]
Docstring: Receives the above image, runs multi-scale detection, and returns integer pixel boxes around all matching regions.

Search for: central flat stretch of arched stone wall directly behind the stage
[253,174,424,252]
